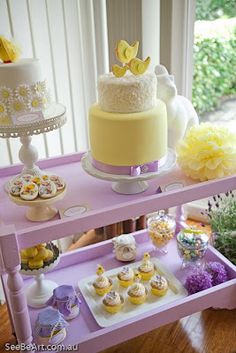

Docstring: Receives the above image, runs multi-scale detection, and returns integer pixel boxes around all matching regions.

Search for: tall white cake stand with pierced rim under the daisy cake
[0,103,66,179]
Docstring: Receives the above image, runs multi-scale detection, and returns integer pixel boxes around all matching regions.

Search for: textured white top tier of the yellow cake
[98,72,157,113]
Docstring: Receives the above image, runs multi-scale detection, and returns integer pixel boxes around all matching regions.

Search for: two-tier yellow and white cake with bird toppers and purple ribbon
[89,41,167,176]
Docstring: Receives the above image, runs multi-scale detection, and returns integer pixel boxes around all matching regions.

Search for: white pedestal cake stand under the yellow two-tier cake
[81,149,176,195]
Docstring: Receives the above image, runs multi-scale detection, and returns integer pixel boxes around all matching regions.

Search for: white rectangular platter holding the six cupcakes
[78,258,187,327]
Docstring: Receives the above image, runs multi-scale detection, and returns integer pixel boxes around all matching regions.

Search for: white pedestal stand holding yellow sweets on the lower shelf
[21,245,60,308]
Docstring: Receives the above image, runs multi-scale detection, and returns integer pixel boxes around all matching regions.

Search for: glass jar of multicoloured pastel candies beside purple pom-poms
[177,228,209,268]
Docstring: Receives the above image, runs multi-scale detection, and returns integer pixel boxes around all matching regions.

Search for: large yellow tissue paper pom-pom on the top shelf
[177,123,236,181]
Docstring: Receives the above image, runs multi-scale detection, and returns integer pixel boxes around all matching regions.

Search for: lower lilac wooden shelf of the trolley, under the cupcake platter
[4,231,236,353]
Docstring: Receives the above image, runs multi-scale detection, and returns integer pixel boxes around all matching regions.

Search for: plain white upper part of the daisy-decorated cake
[0,59,45,90]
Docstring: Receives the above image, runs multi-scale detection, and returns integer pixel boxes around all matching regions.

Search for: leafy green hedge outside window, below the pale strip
[192,33,236,114]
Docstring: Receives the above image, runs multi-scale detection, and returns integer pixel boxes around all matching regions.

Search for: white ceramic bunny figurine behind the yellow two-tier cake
[155,65,199,149]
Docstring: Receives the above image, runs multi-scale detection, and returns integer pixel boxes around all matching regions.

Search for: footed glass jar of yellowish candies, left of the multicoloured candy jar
[147,210,176,254]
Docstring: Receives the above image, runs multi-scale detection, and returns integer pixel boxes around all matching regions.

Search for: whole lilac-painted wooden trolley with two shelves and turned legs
[0,154,236,353]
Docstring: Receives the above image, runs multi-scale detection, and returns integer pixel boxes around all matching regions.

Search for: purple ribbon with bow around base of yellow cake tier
[92,158,158,176]
